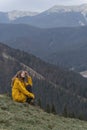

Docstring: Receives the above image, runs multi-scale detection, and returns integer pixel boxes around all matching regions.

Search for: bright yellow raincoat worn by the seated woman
[12,77,34,102]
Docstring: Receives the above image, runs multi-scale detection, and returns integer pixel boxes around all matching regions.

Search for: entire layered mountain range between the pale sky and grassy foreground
[0,5,87,123]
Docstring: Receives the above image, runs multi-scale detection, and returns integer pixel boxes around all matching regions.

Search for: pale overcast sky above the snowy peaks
[0,0,87,12]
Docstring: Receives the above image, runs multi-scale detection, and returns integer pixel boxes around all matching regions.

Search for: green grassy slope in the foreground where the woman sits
[0,95,87,130]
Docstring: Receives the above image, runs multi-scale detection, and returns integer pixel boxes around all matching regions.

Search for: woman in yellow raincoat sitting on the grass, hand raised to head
[12,70,35,103]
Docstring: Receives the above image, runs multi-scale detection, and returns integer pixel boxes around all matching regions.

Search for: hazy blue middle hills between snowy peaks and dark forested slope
[0,24,87,71]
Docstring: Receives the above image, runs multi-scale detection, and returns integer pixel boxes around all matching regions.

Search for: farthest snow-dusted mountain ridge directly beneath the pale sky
[0,4,87,28]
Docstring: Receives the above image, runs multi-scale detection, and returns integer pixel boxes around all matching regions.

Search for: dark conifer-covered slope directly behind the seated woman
[0,43,87,120]
